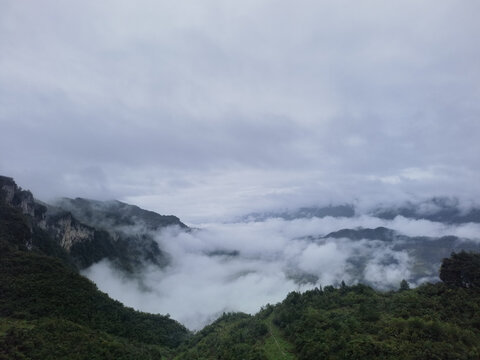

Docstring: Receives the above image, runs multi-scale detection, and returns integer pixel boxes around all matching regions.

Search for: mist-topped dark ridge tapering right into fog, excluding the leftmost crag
[47,198,188,272]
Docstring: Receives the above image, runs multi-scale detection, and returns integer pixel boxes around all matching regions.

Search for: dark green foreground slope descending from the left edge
[0,195,189,359]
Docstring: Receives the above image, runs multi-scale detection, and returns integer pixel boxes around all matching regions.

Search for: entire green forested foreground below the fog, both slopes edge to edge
[0,179,480,360]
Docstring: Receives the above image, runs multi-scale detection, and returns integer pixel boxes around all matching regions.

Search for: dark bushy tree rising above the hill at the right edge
[440,251,480,288]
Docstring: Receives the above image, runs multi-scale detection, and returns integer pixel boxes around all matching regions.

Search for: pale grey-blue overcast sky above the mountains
[0,0,480,222]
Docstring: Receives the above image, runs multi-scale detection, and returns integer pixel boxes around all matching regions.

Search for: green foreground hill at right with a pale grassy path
[176,274,480,360]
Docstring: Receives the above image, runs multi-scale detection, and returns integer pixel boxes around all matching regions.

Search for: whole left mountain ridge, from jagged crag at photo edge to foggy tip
[0,176,188,273]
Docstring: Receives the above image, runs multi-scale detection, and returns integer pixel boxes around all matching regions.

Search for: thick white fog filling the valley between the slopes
[83,215,480,330]
